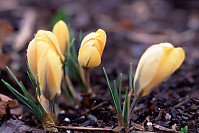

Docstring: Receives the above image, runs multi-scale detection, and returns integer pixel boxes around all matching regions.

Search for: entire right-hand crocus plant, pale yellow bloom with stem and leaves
[103,43,185,130]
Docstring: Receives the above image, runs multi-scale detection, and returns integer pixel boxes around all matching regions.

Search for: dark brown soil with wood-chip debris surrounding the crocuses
[0,0,199,133]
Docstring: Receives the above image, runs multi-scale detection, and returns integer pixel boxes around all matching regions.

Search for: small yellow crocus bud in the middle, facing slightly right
[78,29,106,68]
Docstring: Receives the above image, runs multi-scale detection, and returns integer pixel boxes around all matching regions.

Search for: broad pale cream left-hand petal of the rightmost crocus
[134,45,163,95]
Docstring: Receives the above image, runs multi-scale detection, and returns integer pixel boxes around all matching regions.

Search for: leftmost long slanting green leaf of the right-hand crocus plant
[103,67,120,114]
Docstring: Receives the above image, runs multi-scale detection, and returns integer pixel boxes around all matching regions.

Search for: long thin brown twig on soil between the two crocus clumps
[55,126,113,133]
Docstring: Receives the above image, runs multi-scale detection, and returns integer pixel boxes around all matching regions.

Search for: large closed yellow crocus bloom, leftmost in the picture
[27,32,62,100]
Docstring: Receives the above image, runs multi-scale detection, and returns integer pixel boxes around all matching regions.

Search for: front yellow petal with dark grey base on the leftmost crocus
[37,41,62,100]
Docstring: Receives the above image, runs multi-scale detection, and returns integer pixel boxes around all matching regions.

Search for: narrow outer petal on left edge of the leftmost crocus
[27,39,37,79]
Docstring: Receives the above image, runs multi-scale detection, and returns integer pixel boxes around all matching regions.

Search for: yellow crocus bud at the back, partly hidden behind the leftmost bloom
[53,20,70,55]
